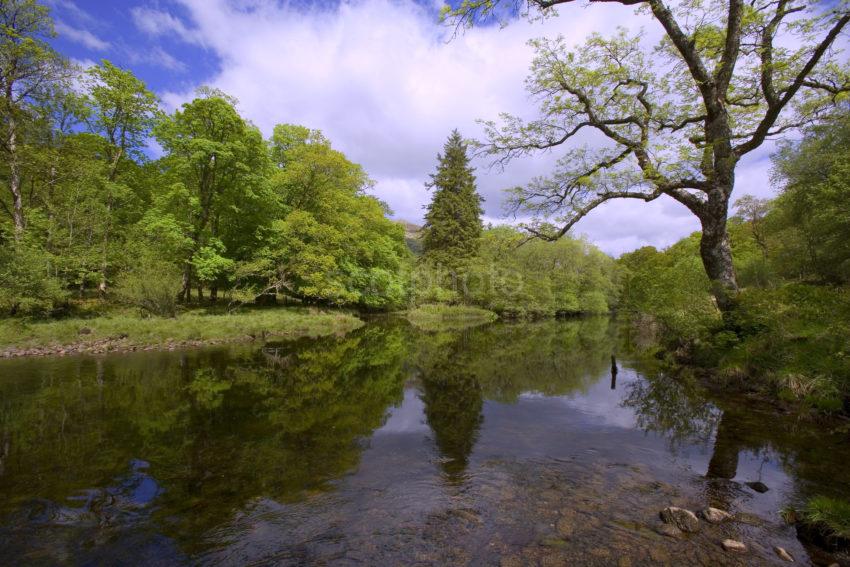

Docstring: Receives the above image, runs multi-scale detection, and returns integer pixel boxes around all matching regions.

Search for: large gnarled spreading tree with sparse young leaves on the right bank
[446,0,850,313]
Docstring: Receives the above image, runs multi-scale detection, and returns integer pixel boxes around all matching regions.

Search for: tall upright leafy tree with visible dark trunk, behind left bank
[152,89,269,301]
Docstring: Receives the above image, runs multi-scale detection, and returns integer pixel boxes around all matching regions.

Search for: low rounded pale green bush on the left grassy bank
[116,258,183,317]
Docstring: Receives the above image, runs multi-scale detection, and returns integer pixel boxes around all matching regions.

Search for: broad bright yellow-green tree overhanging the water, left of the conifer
[254,124,409,308]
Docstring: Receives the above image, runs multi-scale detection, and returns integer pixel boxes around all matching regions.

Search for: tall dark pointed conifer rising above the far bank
[422,130,484,266]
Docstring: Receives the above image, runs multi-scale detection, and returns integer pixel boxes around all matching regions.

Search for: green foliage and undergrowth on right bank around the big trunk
[619,116,850,418]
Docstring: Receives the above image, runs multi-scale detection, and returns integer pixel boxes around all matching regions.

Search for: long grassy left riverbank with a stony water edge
[0,307,363,358]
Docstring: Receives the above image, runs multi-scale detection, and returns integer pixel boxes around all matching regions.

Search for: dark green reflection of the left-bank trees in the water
[0,329,407,560]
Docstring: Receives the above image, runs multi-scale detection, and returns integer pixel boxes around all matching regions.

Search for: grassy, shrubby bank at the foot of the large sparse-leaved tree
[624,284,850,413]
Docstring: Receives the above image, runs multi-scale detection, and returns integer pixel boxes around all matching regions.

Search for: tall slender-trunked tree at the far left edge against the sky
[0,0,67,238]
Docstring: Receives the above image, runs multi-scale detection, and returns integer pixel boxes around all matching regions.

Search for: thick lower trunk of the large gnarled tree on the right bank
[699,190,738,314]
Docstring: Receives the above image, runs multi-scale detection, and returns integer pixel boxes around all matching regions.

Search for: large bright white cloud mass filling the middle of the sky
[144,0,776,254]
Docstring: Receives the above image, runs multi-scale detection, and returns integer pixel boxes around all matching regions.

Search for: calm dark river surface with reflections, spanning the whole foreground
[0,319,850,566]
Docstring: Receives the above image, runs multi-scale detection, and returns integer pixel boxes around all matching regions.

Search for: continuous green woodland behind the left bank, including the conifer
[0,5,615,324]
